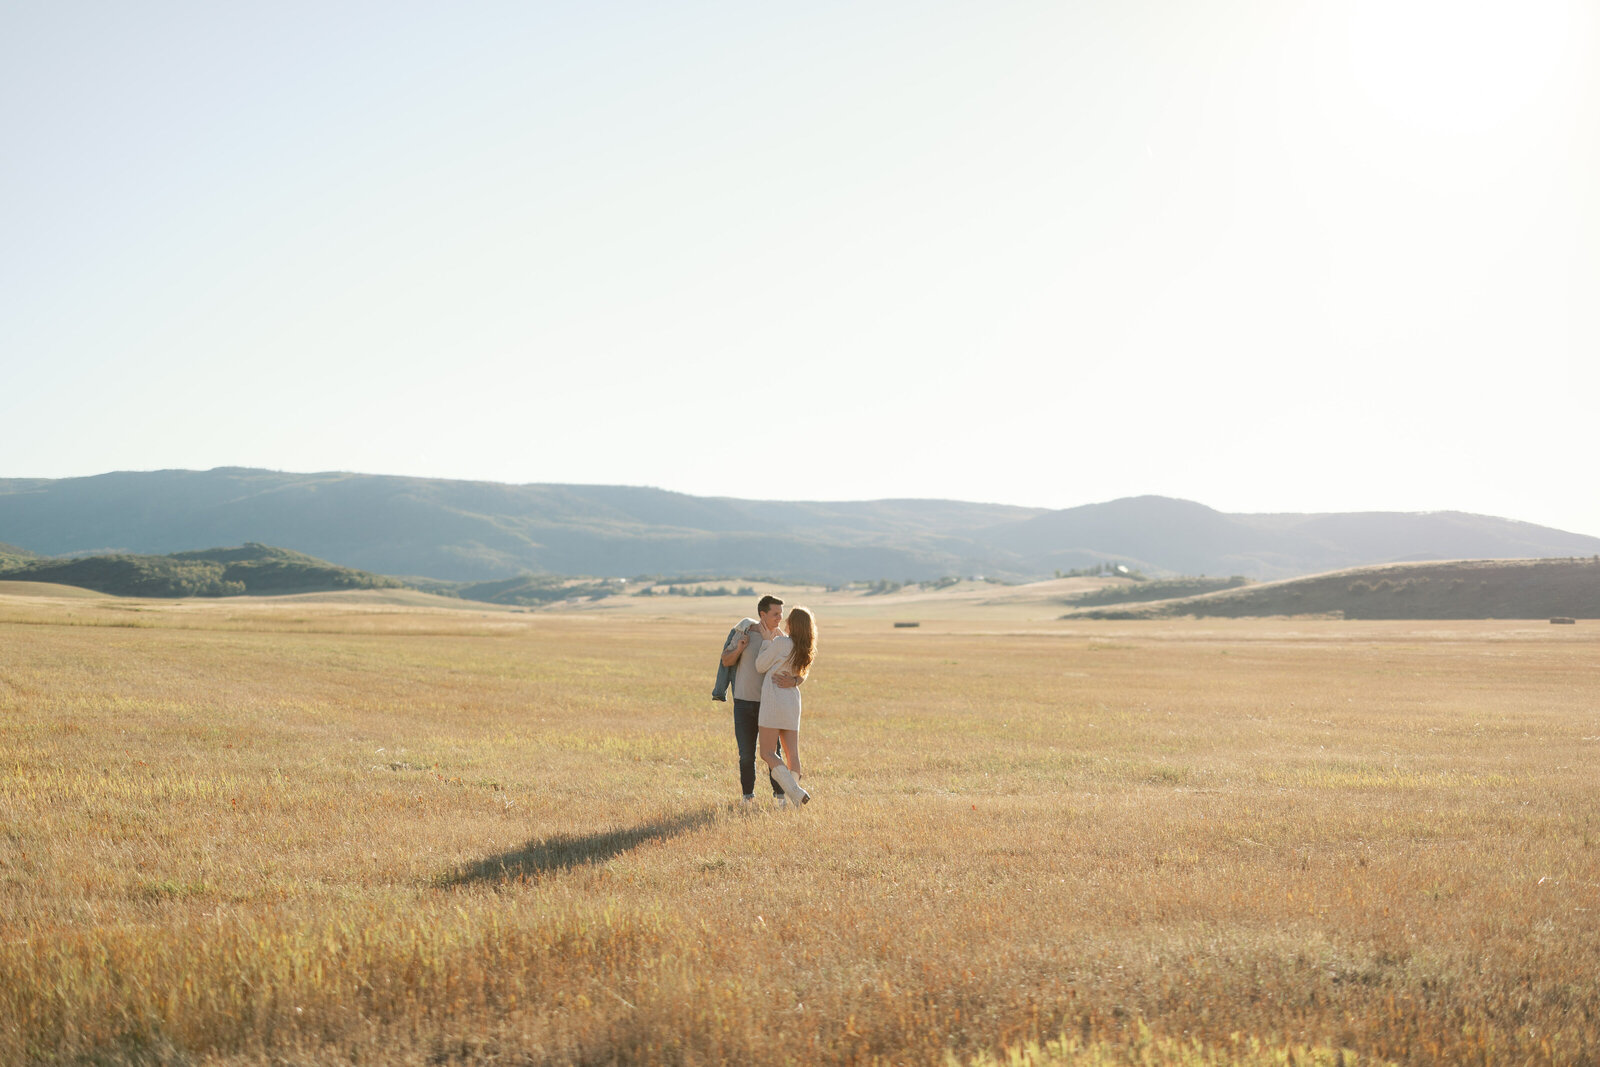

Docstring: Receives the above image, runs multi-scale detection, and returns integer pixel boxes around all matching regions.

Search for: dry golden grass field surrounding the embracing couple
[0,587,1600,1065]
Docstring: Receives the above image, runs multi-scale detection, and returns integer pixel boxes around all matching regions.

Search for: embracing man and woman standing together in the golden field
[712,597,816,808]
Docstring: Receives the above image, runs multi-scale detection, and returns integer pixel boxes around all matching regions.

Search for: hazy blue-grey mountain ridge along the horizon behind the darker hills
[0,467,1600,582]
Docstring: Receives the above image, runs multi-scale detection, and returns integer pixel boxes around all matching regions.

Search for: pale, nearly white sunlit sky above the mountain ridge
[0,0,1600,534]
